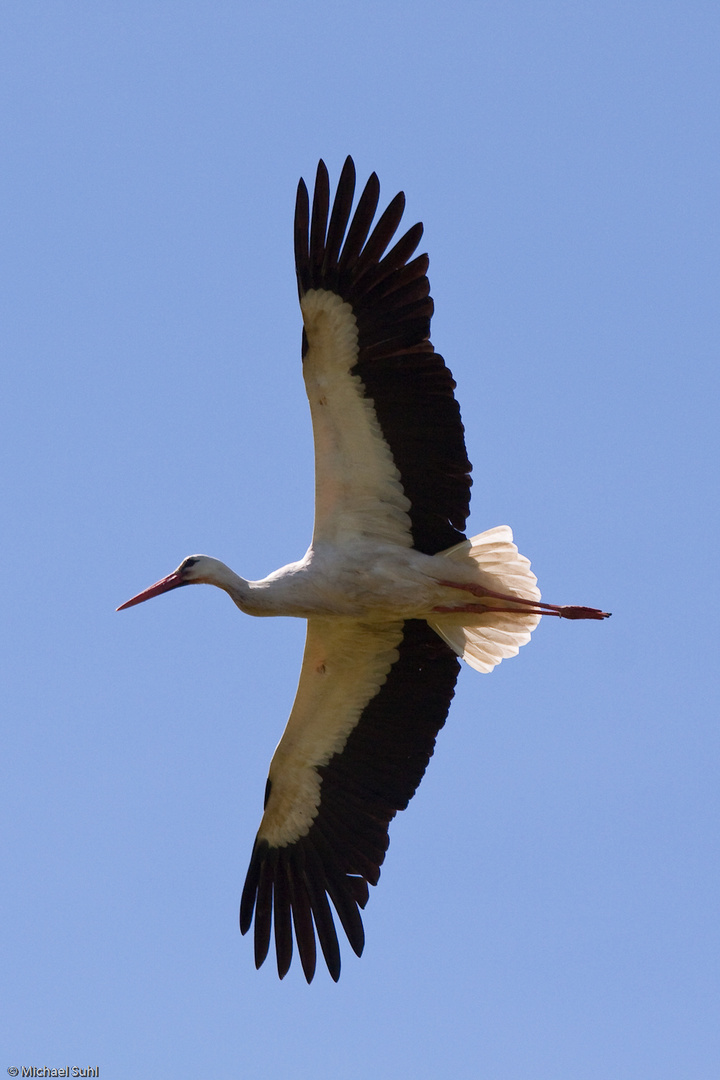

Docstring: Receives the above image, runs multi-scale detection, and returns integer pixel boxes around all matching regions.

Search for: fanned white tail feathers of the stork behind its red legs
[427,525,541,672]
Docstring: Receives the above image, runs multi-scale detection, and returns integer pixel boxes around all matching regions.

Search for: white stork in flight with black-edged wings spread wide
[119,158,607,982]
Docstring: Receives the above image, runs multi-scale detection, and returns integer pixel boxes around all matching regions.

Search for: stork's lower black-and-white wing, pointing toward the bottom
[240,619,460,982]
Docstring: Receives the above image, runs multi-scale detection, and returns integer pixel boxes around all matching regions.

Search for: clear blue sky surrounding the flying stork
[0,0,720,1080]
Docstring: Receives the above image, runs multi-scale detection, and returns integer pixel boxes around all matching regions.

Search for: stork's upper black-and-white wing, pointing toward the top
[295,158,471,554]
